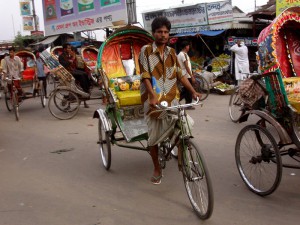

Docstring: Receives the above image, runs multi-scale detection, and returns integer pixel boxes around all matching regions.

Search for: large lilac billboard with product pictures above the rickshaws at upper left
[43,0,127,36]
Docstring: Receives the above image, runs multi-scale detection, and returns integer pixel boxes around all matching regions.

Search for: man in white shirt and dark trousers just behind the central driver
[177,41,195,109]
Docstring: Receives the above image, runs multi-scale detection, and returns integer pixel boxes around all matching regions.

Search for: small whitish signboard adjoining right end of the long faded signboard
[206,1,233,24]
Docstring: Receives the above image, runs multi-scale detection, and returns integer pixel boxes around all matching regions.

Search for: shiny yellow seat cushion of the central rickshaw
[115,90,142,107]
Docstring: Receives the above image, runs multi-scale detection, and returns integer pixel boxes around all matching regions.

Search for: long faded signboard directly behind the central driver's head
[143,4,207,31]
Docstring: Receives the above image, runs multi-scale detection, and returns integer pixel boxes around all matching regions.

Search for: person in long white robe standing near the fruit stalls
[230,40,250,85]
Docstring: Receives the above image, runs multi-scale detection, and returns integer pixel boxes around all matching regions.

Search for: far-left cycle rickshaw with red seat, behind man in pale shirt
[3,50,46,121]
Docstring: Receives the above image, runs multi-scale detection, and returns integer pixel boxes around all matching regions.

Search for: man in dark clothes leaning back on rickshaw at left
[58,43,90,108]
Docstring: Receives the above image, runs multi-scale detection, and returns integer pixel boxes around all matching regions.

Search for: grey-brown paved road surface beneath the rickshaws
[0,92,300,225]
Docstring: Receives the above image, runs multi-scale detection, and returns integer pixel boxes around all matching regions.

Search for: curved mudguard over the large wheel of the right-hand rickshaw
[239,110,292,145]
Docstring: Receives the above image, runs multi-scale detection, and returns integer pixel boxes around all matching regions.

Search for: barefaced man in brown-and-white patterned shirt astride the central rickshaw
[139,17,201,184]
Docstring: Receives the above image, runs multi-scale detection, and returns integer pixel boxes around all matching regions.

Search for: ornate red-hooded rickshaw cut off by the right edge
[235,7,300,196]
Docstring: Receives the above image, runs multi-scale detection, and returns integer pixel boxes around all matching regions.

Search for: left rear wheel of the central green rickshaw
[98,119,111,170]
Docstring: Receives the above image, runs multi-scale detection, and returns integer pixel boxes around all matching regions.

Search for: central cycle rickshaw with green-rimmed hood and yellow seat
[94,25,213,219]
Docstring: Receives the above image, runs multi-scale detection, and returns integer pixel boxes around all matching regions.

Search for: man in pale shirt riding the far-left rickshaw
[1,47,23,96]
